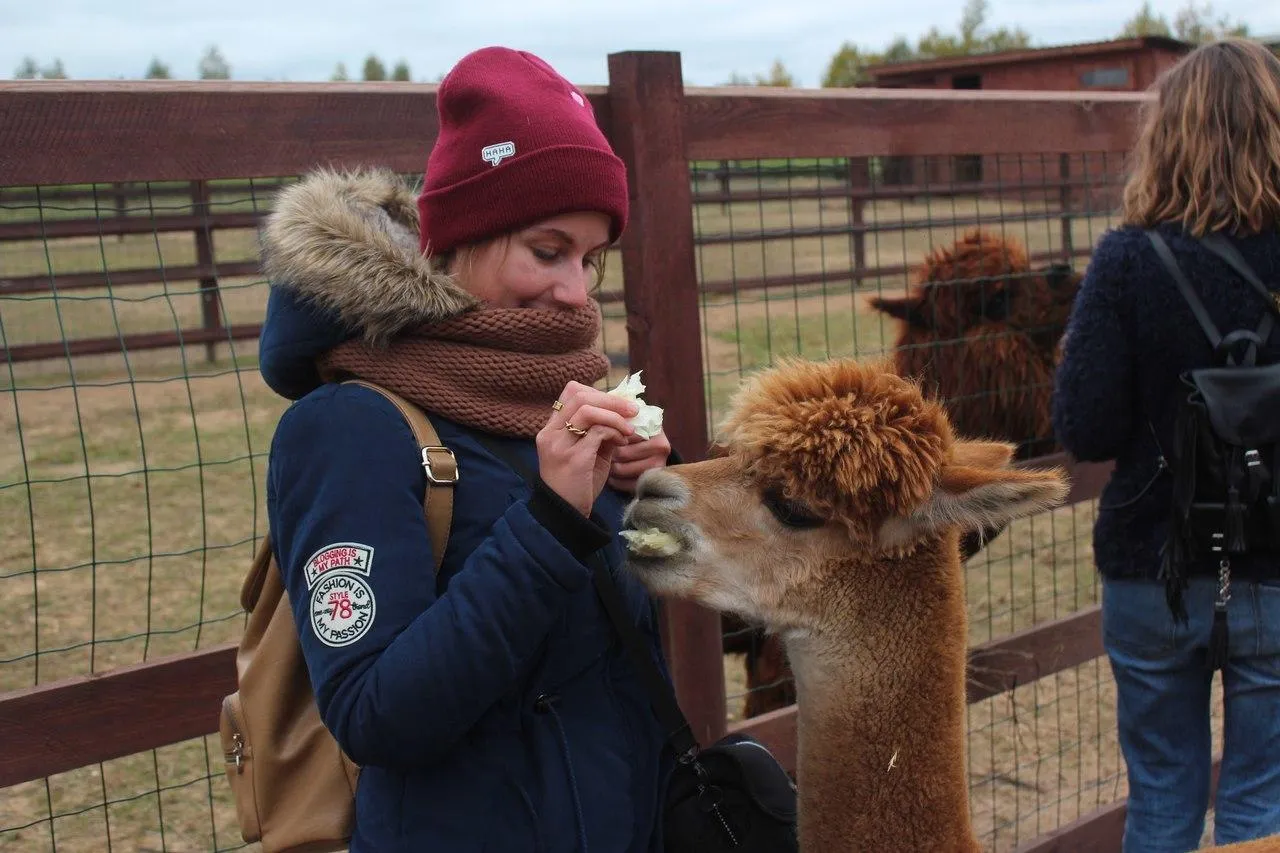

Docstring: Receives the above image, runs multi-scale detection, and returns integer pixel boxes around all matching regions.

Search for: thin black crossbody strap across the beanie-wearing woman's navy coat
[474,432,698,761]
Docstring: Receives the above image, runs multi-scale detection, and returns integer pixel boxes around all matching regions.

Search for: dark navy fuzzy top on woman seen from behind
[1053,225,1280,579]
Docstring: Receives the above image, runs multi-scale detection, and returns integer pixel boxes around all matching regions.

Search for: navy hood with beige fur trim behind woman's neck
[259,169,476,400]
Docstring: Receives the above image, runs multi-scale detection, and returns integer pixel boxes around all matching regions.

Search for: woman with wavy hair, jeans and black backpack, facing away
[1053,38,1280,853]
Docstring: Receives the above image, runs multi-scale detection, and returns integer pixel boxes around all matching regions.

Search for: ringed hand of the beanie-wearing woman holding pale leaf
[536,382,640,516]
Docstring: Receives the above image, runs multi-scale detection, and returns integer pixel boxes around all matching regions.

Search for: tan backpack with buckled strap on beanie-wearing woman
[219,380,458,853]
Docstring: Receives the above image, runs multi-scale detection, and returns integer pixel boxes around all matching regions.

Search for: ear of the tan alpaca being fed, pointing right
[911,447,1068,533]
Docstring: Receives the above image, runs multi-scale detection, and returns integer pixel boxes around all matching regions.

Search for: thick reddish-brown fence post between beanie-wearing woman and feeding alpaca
[609,51,726,745]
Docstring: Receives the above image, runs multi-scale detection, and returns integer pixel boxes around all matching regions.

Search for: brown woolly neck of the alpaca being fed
[787,548,978,853]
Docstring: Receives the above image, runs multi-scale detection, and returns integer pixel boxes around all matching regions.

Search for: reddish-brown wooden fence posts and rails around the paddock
[0,53,1142,852]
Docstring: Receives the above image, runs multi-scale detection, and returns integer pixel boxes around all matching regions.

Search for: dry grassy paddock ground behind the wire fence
[0,171,1198,850]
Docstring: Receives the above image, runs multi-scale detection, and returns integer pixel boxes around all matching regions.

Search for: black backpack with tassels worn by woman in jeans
[1147,231,1280,670]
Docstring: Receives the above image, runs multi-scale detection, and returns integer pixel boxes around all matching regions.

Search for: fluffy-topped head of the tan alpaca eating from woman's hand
[626,360,1065,629]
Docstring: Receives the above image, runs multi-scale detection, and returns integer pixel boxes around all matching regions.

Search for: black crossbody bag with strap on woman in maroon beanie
[477,434,800,853]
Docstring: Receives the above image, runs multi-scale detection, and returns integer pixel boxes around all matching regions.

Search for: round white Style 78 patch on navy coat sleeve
[306,542,378,647]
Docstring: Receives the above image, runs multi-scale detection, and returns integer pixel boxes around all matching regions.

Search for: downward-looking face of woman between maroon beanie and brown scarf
[449,211,609,309]
